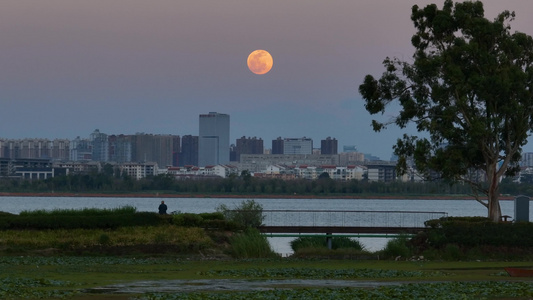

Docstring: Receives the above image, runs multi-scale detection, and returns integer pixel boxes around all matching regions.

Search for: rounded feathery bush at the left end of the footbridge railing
[216,200,265,228]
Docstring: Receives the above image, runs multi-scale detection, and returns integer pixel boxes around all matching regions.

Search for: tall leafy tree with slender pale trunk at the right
[359,0,533,221]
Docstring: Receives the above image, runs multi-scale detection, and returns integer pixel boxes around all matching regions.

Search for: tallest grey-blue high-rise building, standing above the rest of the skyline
[198,112,230,167]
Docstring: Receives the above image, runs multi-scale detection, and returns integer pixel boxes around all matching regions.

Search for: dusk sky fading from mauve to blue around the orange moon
[0,0,533,160]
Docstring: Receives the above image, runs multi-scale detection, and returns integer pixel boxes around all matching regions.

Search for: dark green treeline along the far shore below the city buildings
[0,173,533,199]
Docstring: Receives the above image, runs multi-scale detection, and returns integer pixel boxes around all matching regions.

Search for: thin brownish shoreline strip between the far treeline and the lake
[0,192,515,201]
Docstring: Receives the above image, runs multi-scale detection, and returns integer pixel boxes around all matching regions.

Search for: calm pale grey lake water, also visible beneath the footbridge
[0,197,533,255]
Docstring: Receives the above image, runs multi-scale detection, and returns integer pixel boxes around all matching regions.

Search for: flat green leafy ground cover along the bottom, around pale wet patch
[0,256,533,300]
